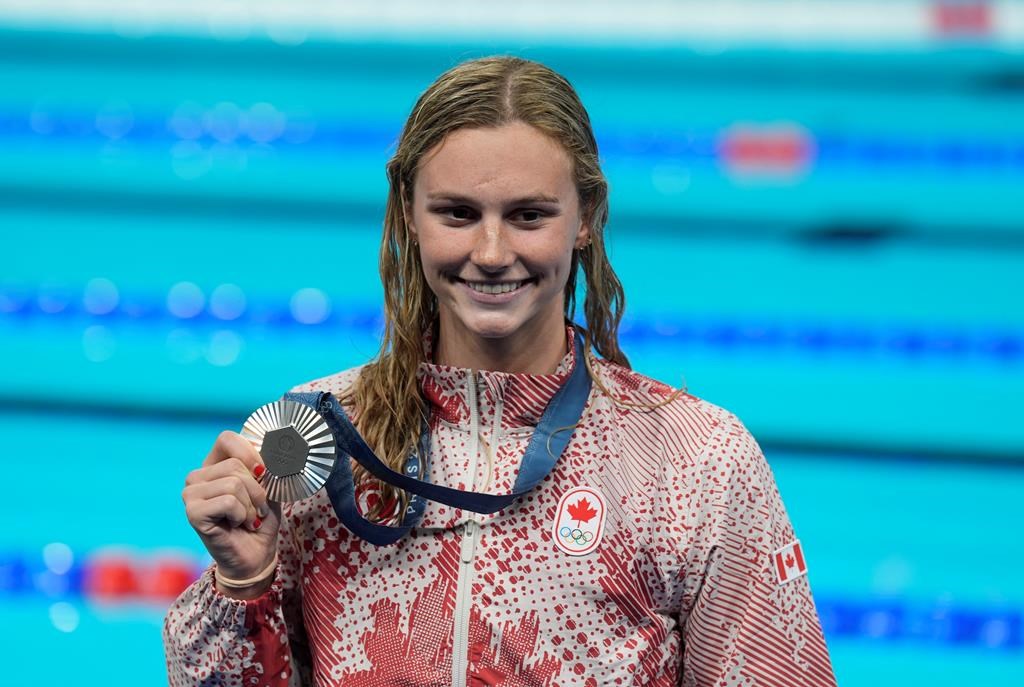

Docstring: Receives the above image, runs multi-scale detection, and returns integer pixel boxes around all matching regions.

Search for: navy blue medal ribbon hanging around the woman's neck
[285,334,591,546]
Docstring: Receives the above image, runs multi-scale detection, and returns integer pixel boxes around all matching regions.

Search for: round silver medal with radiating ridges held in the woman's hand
[241,400,336,501]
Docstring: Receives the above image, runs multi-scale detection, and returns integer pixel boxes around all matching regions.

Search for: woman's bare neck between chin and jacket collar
[434,318,568,375]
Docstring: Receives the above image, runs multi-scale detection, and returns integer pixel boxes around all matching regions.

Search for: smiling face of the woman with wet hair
[409,122,589,360]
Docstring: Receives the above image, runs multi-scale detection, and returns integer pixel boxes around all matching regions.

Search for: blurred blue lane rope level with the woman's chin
[0,285,1024,364]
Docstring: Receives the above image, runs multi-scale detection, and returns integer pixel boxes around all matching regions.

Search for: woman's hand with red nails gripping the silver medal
[181,431,281,598]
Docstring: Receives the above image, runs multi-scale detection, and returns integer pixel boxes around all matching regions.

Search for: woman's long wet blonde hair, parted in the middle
[341,56,629,516]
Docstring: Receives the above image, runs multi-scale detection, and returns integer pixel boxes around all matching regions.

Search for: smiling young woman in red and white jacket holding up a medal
[164,57,835,687]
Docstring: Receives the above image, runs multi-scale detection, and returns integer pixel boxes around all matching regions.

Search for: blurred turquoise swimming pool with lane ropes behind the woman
[0,0,1024,687]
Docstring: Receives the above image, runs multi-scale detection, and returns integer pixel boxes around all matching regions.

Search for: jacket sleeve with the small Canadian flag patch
[681,416,836,687]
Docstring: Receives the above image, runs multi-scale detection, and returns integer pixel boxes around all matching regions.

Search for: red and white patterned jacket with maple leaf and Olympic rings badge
[164,339,835,687]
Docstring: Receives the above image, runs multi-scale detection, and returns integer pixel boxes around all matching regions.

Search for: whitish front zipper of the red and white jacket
[452,371,480,687]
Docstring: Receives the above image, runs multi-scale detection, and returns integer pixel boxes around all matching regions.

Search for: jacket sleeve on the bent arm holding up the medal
[164,499,311,687]
